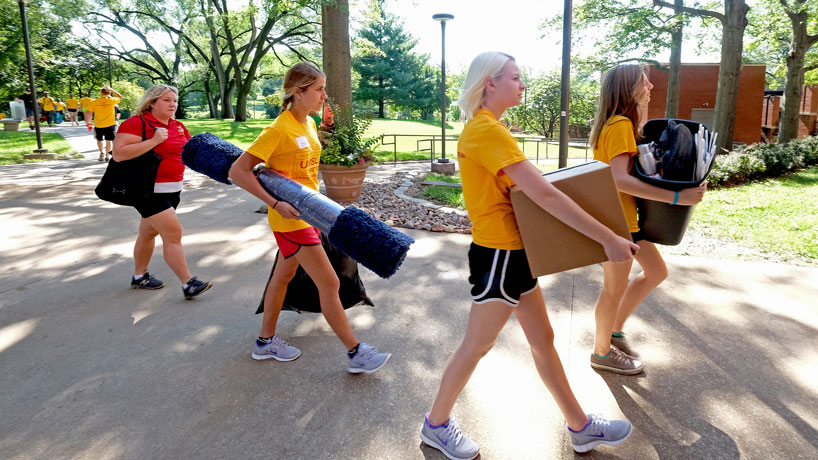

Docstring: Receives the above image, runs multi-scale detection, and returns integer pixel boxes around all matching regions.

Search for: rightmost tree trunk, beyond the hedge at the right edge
[778,11,818,144]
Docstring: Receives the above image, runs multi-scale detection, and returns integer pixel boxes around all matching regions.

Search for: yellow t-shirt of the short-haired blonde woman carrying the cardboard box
[457,108,527,249]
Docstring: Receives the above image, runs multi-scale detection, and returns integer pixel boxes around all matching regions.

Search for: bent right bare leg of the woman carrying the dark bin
[611,241,667,332]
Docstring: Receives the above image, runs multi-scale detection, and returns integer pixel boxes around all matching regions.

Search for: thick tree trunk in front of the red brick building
[713,0,750,150]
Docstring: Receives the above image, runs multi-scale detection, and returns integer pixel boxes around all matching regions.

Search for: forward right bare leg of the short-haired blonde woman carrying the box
[514,284,588,430]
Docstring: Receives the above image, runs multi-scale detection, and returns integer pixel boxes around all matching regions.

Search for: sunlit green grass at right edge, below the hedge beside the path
[690,166,818,261]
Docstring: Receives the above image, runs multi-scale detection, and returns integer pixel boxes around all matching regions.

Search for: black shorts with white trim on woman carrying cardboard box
[469,243,537,307]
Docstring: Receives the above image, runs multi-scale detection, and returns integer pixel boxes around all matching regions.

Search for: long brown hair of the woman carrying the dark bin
[589,64,645,148]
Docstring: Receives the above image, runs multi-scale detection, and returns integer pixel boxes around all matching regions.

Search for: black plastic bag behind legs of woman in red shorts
[256,233,375,314]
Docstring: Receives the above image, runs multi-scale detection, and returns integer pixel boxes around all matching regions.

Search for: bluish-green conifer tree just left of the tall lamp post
[352,0,423,118]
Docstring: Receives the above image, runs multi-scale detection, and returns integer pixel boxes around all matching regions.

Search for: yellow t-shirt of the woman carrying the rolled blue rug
[247,110,321,232]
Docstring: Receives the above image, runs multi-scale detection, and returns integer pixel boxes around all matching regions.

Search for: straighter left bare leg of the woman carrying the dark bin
[594,262,632,356]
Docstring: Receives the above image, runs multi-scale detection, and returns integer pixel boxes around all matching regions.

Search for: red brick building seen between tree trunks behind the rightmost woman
[648,64,764,144]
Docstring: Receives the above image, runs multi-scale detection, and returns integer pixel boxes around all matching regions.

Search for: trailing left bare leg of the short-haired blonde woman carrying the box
[429,302,513,425]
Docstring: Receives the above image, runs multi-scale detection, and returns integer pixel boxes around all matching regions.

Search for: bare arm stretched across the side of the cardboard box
[502,160,639,262]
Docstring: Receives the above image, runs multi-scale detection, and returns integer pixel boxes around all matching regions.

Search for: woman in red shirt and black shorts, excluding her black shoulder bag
[114,85,212,299]
